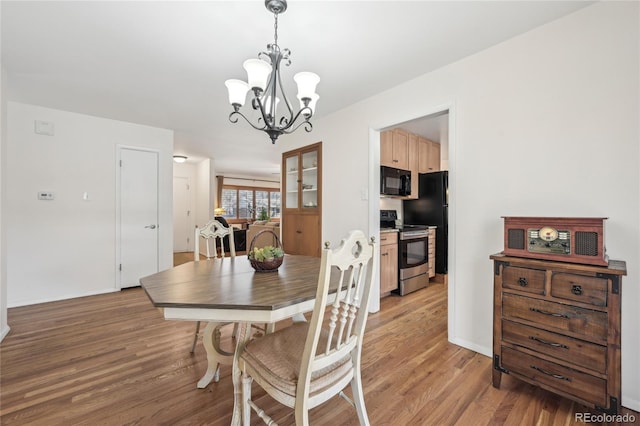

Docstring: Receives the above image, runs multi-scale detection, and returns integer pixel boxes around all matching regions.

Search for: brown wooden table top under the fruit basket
[140,255,320,310]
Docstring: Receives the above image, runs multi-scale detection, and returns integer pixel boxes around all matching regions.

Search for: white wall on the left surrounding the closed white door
[3,102,173,306]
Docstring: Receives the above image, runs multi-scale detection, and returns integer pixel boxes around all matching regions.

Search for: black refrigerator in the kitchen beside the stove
[402,170,449,274]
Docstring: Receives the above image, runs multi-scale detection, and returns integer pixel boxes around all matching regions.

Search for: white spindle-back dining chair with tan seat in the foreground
[239,231,378,426]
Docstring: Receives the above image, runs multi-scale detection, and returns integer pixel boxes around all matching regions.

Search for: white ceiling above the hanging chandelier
[0,0,592,178]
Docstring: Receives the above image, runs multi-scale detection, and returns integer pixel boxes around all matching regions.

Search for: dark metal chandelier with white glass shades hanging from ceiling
[224,0,320,144]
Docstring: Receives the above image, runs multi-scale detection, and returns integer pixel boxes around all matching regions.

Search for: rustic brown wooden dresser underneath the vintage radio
[491,254,626,414]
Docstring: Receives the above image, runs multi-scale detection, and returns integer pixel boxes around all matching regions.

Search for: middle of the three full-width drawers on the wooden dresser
[502,320,607,373]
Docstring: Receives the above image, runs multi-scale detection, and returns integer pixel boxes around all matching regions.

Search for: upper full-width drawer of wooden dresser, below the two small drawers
[502,293,607,344]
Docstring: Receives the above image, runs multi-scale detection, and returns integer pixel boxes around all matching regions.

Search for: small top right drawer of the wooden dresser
[551,272,608,306]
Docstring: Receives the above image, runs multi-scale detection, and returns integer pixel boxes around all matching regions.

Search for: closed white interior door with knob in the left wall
[118,148,159,288]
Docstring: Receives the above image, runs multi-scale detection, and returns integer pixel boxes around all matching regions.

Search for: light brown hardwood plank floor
[0,255,640,426]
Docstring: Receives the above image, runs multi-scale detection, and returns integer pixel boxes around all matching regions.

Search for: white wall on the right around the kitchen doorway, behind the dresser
[279,2,640,410]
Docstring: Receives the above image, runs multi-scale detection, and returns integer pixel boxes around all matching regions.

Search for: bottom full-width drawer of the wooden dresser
[502,347,609,407]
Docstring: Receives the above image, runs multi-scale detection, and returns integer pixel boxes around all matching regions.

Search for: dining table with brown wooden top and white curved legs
[140,254,320,425]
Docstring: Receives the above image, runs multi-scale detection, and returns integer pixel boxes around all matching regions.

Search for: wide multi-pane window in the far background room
[221,185,280,223]
